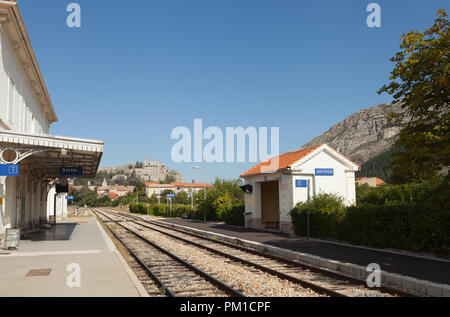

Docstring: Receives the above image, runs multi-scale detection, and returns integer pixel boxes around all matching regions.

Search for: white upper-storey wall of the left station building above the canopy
[0,26,49,134]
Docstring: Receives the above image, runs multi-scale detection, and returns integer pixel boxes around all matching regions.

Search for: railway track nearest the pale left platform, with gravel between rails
[96,211,244,297]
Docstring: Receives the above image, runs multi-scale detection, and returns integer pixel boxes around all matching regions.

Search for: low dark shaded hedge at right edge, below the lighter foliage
[338,203,450,254]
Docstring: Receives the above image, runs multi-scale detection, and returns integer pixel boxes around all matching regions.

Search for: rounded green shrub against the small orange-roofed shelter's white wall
[291,194,345,238]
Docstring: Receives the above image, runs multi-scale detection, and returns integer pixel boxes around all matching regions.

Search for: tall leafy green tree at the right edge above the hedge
[378,10,450,183]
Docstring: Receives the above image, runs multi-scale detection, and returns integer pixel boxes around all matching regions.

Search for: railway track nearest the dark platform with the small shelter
[94,210,411,297]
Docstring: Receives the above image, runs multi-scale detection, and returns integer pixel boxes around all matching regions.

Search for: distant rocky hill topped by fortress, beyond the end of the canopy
[99,159,183,182]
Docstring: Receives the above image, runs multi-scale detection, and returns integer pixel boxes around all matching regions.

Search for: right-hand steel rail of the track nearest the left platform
[94,212,246,297]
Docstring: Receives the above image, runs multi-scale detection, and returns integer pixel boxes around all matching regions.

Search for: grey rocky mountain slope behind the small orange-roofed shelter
[303,104,408,165]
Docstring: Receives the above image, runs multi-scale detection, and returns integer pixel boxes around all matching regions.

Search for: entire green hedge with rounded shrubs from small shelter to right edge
[291,184,450,254]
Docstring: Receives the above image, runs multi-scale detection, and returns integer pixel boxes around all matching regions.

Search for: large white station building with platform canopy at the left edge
[0,0,104,244]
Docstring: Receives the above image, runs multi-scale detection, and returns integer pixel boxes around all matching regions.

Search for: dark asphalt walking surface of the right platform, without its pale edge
[159,219,450,285]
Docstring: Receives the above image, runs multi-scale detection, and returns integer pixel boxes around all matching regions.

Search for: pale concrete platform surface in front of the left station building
[0,218,139,297]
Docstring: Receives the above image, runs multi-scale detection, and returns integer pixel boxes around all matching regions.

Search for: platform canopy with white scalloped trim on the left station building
[0,131,104,179]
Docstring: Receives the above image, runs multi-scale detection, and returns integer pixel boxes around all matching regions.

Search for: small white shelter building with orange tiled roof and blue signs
[241,144,360,233]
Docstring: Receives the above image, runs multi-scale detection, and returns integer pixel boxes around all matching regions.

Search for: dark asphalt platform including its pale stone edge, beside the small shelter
[158,219,450,296]
